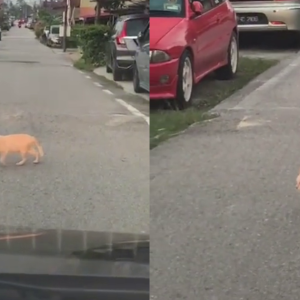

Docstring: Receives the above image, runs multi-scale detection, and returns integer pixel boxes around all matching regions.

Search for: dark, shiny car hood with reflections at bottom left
[0,227,149,277]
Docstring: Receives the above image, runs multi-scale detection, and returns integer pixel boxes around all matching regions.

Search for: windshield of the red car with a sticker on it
[149,0,185,17]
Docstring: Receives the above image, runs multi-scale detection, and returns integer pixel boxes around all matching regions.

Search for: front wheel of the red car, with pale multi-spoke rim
[175,51,194,110]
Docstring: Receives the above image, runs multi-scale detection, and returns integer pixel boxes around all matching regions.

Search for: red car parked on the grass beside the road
[149,0,239,109]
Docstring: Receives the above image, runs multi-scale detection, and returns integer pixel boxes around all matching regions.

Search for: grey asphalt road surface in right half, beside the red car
[150,51,300,300]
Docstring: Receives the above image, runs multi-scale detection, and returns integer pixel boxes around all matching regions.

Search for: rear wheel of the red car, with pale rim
[216,32,239,80]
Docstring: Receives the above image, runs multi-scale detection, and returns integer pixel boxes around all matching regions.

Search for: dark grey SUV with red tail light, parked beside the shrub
[106,14,149,81]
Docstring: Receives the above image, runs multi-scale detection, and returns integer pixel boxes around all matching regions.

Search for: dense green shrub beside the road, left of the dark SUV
[71,25,112,67]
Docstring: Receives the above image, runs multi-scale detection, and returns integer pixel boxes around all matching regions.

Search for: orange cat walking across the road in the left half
[0,134,44,166]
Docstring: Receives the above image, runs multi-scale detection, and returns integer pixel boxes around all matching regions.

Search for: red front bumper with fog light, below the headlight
[150,59,178,100]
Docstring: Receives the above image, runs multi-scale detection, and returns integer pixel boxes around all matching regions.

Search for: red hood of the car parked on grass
[150,17,184,49]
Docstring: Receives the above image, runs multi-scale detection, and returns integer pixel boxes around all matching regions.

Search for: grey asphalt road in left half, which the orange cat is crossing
[0,27,149,232]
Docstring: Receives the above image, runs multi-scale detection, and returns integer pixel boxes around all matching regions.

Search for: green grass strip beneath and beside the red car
[150,57,278,149]
